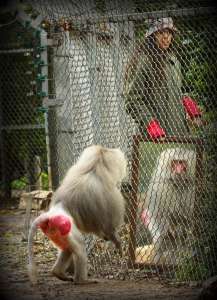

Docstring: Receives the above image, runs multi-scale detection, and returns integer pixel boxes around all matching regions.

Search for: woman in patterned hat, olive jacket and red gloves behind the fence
[125,18,202,139]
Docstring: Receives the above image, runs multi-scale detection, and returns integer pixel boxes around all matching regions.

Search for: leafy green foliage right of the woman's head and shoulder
[176,17,217,110]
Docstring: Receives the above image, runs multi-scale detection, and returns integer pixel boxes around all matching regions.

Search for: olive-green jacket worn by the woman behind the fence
[125,49,201,136]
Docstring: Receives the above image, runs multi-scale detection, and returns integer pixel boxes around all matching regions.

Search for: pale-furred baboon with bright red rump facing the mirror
[28,146,126,283]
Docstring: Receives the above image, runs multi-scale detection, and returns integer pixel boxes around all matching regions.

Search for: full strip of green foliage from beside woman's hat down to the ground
[173,18,217,281]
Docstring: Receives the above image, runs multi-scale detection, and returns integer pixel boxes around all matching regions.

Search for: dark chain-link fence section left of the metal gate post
[0,16,47,197]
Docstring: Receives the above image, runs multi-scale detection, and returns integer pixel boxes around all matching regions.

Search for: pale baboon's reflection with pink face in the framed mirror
[141,148,196,262]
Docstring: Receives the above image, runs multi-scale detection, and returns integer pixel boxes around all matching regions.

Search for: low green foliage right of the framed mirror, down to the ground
[176,123,217,281]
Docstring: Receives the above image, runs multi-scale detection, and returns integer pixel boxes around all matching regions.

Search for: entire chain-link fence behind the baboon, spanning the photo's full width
[0,0,217,281]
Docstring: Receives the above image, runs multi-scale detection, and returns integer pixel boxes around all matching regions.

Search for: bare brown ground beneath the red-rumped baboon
[0,208,201,300]
